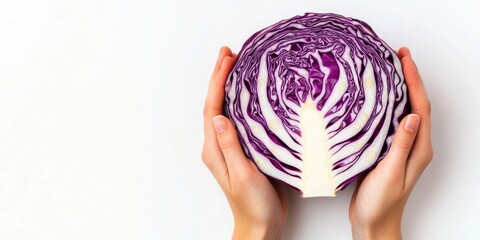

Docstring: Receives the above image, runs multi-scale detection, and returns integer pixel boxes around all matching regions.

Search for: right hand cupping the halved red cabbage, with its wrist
[349,48,433,239]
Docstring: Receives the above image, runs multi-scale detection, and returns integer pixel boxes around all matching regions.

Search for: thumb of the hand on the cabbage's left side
[212,115,249,173]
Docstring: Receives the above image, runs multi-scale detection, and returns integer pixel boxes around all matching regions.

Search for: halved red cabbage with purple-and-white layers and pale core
[225,13,408,197]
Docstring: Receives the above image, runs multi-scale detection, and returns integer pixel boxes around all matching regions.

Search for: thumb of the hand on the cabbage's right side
[385,114,420,173]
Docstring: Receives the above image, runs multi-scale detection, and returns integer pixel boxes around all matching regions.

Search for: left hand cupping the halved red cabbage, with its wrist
[202,47,287,239]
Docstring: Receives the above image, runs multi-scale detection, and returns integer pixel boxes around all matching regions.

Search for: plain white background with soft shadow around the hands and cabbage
[0,0,480,240]
